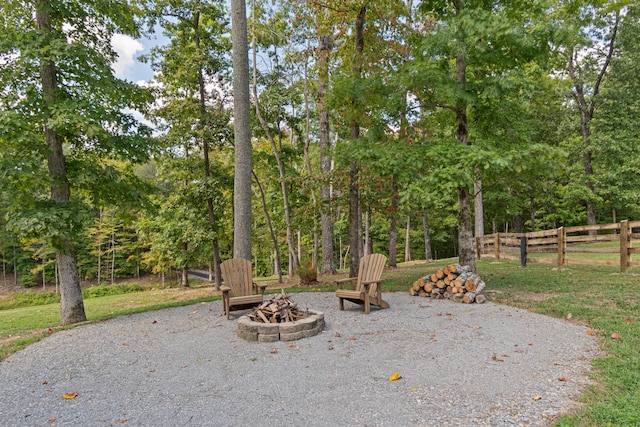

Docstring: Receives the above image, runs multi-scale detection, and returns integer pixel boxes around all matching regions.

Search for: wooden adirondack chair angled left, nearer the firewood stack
[336,254,389,314]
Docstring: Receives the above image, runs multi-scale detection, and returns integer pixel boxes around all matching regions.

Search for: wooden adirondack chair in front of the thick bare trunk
[220,258,267,319]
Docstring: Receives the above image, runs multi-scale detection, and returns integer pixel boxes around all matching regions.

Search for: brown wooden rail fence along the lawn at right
[475,220,640,273]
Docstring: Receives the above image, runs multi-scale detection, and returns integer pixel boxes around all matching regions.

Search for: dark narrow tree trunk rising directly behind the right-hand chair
[349,6,367,277]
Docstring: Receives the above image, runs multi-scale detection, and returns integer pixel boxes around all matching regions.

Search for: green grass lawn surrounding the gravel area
[0,259,640,426]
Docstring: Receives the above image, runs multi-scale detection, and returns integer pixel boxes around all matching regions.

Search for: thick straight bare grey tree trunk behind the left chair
[231,0,252,261]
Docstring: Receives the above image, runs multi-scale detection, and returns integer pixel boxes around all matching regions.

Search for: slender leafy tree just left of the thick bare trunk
[150,0,229,287]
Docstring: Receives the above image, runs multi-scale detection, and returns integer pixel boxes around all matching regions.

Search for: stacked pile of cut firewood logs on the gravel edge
[409,264,487,304]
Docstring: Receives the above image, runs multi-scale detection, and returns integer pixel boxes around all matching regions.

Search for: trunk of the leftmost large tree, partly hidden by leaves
[36,0,87,326]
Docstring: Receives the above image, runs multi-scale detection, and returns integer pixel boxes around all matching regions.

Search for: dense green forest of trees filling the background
[0,0,640,298]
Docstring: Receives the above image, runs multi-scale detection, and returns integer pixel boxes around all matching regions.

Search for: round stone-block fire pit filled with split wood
[237,292,324,342]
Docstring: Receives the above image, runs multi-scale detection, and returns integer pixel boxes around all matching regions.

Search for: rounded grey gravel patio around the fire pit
[0,292,598,426]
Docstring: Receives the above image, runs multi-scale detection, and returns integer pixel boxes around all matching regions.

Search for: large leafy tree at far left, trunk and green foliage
[0,0,149,325]
